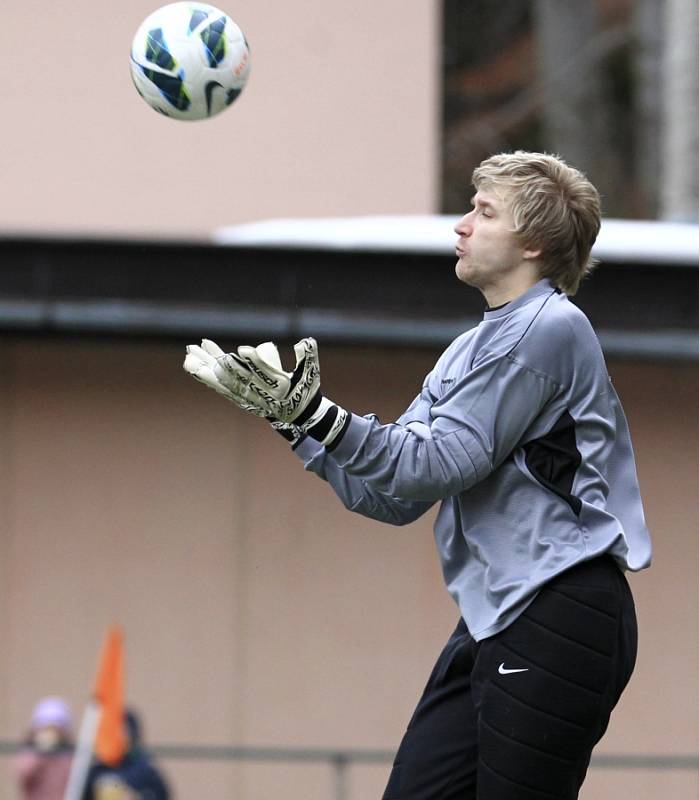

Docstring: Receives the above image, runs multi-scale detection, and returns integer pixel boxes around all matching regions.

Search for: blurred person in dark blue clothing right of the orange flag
[82,710,171,800]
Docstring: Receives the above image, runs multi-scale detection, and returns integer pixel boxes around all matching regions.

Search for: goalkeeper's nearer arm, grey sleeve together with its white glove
[189,339,560,502]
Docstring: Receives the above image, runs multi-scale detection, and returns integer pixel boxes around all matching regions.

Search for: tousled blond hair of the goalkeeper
[472,150,601,295]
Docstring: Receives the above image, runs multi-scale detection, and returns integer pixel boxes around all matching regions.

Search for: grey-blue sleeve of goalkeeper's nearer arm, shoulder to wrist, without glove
[330,356,559,502]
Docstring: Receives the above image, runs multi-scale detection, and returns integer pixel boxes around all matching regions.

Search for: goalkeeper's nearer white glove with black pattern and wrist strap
[214,337,351,448]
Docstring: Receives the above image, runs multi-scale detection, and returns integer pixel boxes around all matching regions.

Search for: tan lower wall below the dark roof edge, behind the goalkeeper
[0,340,699,800]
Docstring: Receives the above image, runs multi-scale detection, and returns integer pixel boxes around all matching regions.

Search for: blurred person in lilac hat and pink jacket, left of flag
[13,697,73,800]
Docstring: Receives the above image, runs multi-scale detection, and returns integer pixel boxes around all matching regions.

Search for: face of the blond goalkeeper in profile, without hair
[454,187,525,291]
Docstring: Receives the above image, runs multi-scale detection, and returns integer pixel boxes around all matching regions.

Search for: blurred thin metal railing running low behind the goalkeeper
[0,741,699,800]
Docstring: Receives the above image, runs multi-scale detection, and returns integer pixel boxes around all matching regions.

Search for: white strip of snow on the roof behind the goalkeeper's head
[213,215,699,264]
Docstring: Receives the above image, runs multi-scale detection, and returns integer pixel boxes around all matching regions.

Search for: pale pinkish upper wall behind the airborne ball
[0,0,441,236]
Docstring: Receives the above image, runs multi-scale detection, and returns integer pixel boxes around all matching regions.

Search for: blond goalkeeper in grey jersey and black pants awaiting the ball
[185,152,651,800]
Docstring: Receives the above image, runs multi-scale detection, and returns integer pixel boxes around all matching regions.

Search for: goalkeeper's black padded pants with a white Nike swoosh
[384,556,637,800]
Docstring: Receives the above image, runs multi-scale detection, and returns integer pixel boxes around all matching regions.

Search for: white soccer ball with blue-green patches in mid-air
[131,2,250,120]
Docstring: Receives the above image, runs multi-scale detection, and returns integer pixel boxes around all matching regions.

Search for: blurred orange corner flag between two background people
[93,626,128,766]
